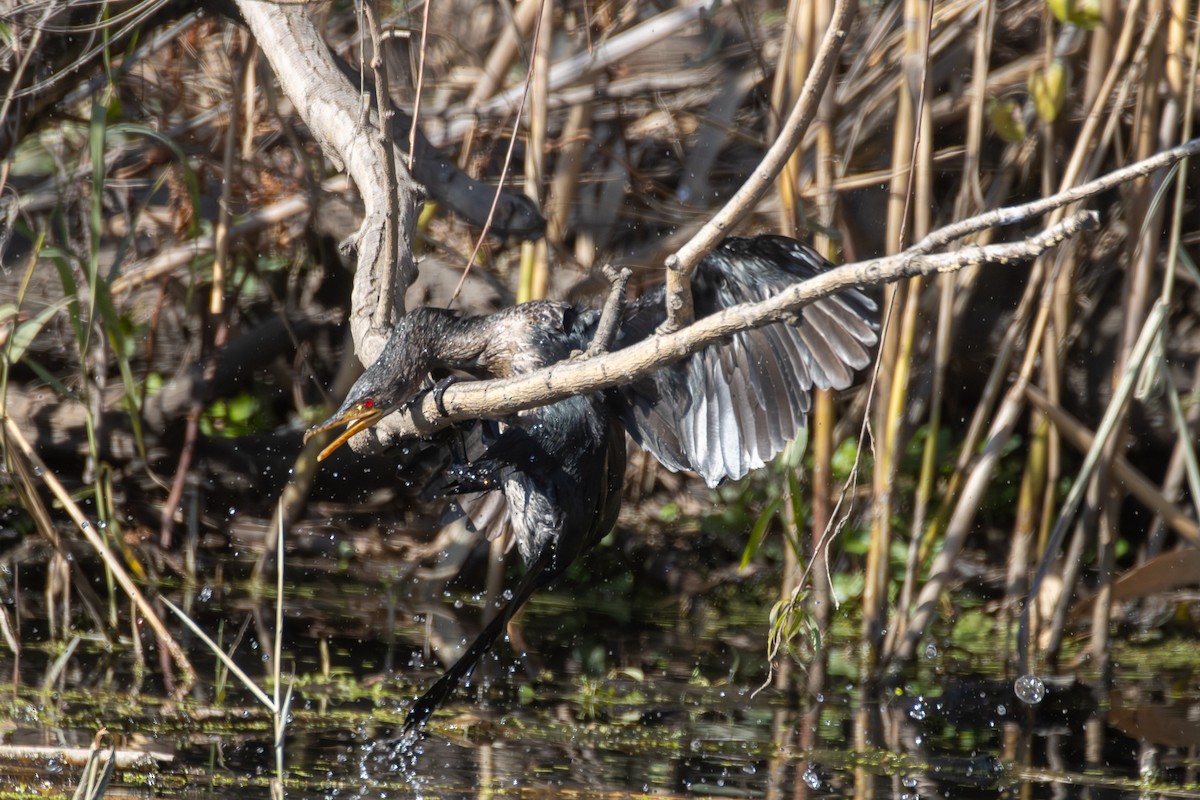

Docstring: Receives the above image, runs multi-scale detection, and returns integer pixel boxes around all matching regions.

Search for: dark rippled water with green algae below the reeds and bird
[0,546,1200,800]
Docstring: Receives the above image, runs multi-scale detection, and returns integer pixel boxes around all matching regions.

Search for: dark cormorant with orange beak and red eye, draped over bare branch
[310,236,876,730]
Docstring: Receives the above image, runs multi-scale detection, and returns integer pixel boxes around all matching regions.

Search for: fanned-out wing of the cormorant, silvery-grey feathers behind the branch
[613,236,877,486]
